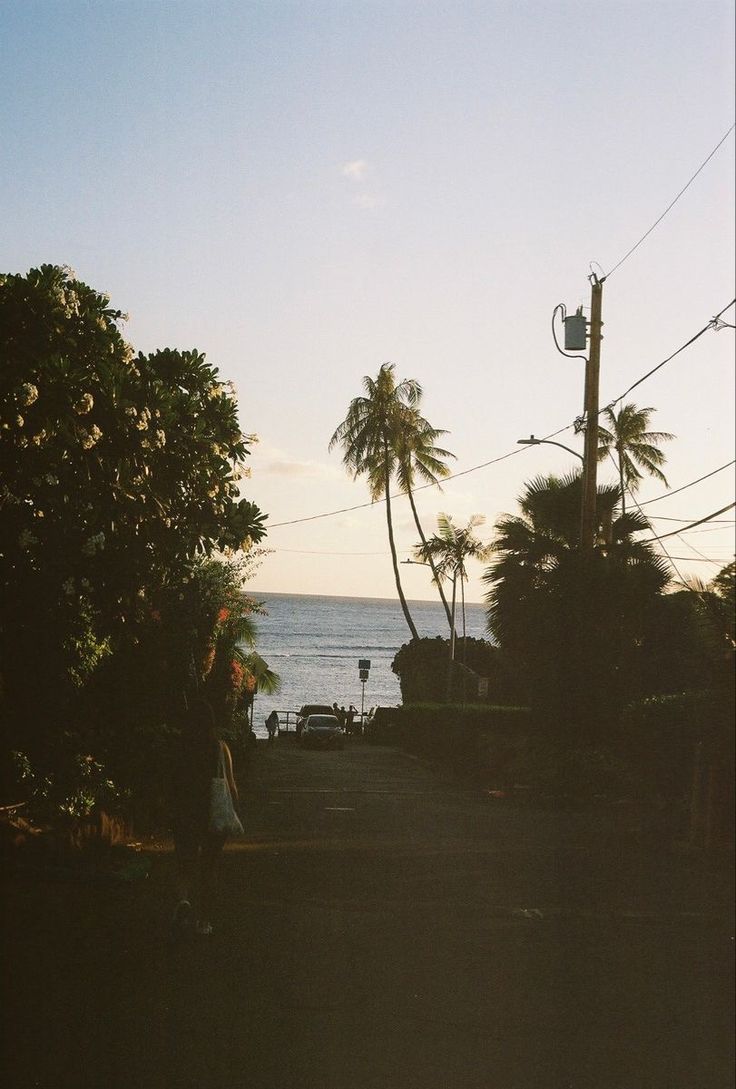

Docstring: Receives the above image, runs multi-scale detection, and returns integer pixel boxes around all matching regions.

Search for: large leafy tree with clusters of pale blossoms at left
[0,265,266,753]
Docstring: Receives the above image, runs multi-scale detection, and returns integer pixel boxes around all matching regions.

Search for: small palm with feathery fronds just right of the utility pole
[598,402,675,513]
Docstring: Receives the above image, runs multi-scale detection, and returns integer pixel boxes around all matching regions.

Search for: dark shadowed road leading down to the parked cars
[0,739,734,1089]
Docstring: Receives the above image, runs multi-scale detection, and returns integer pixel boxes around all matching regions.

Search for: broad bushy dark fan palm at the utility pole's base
[483,473,670,736]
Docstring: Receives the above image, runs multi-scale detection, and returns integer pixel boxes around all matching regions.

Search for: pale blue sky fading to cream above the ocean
[0,0,735,601]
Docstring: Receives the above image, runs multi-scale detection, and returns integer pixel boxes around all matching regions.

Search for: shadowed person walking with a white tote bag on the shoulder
[172,697,237,937]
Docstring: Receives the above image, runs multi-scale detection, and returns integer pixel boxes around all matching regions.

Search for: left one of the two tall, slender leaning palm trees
[328,363,421,639]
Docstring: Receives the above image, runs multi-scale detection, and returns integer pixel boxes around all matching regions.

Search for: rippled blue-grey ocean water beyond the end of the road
[248,588,486,737]
